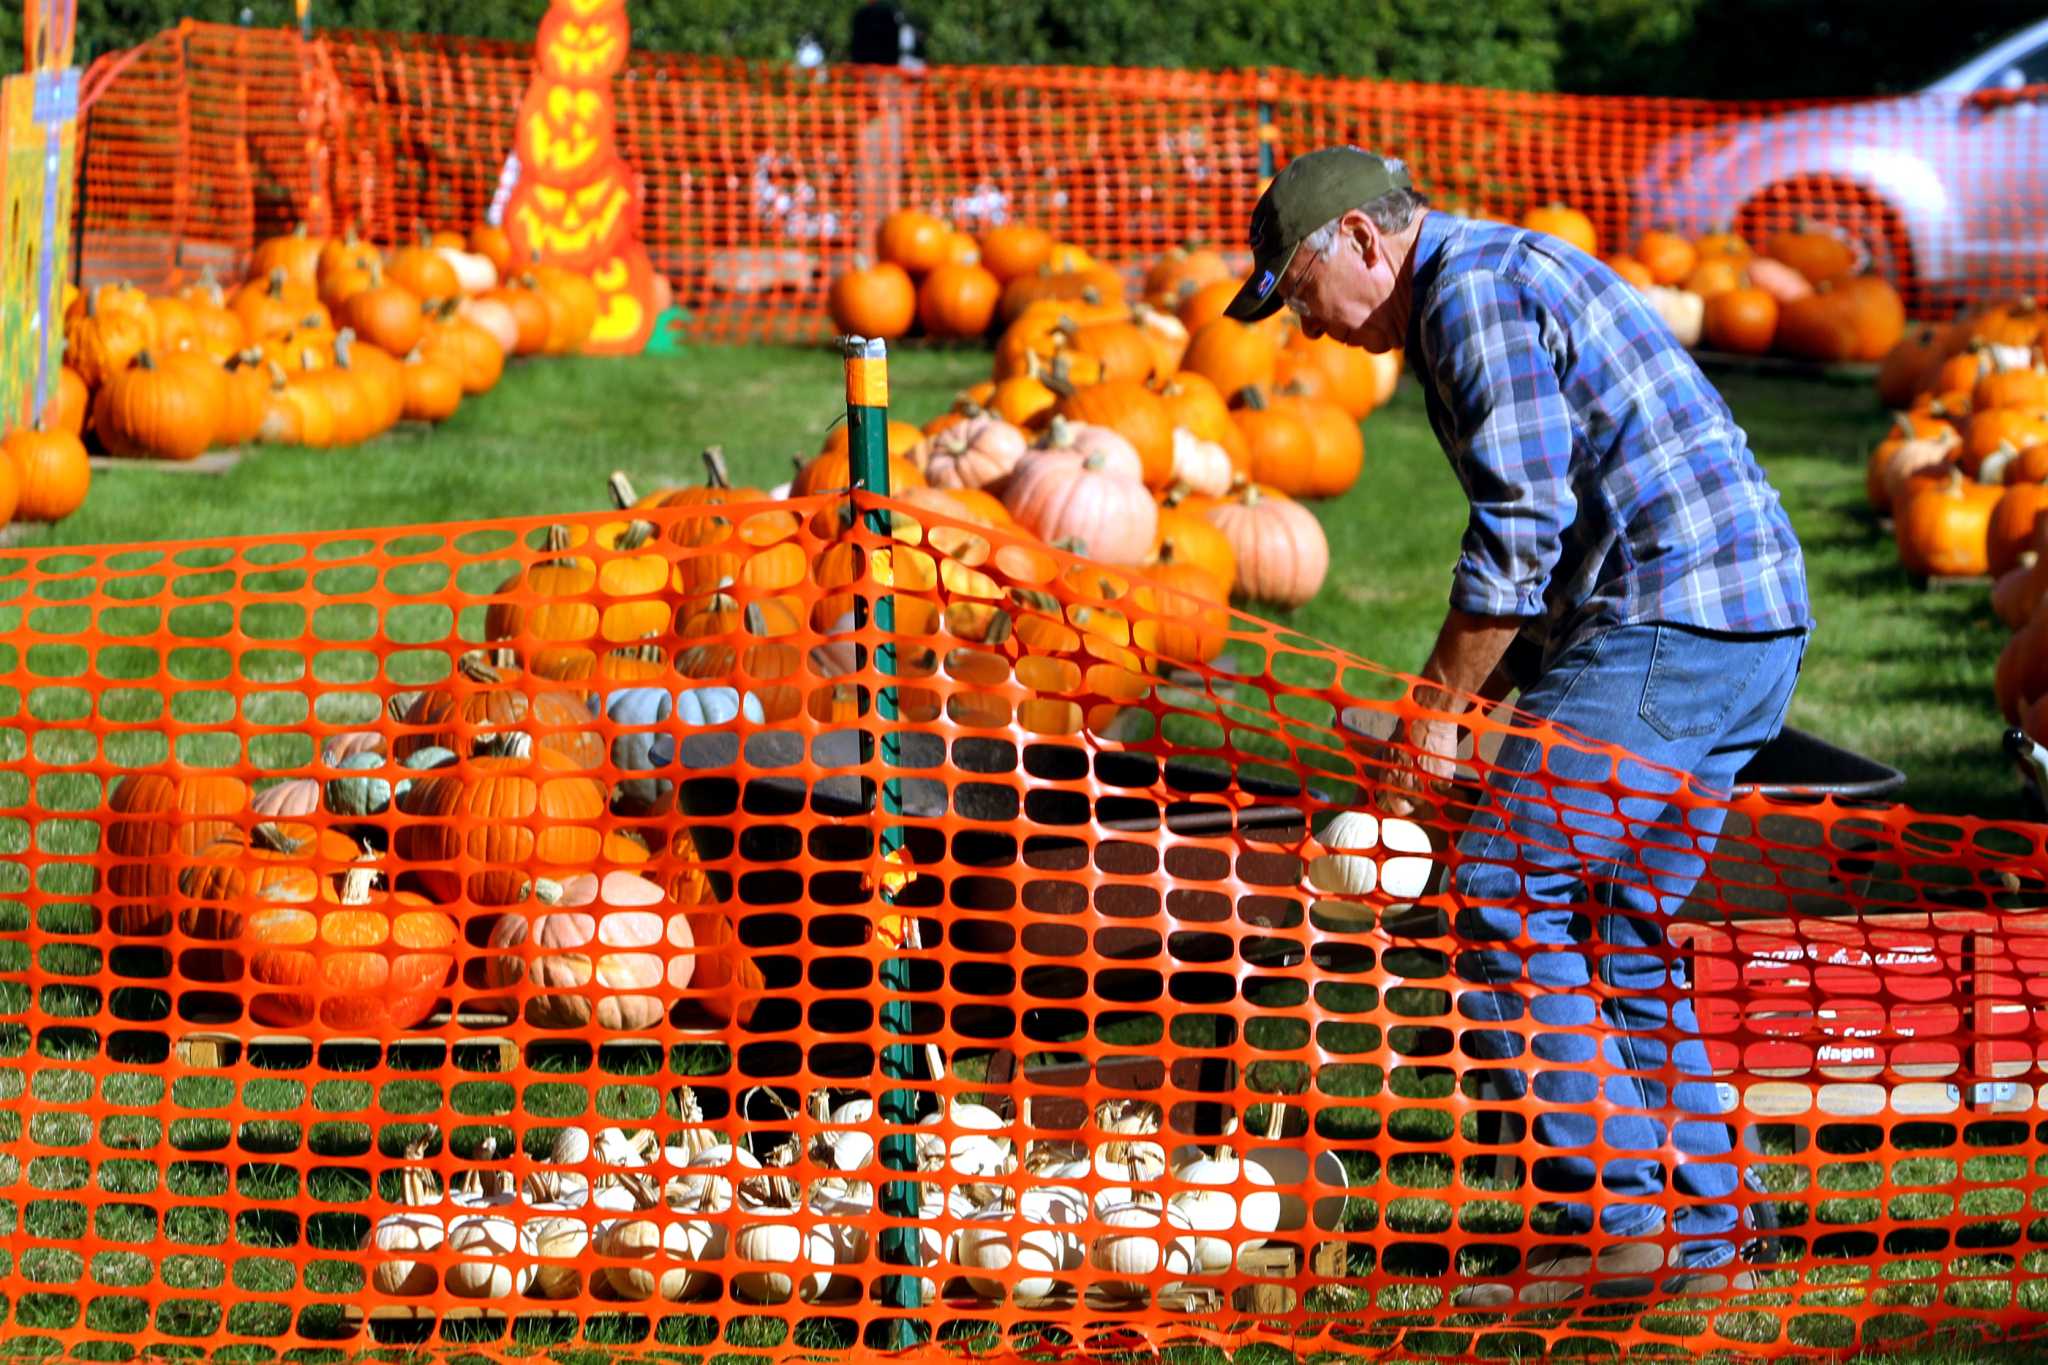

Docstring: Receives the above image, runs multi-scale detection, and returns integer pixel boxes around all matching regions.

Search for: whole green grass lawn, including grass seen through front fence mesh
[0,341,2048,1365]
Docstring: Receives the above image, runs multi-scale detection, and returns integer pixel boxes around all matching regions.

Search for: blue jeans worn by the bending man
[1452,626,1806,1269]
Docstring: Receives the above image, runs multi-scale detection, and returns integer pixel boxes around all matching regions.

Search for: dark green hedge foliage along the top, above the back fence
[0,0,2038,98]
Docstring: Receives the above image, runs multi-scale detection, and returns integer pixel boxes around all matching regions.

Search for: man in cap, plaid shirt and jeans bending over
[1229,147,1815,1306]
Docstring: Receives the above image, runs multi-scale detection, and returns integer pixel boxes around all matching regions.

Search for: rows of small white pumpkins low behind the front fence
[346,1087,1354,1322]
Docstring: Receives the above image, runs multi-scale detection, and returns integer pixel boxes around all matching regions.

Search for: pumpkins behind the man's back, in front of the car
[1522,205,1907,364]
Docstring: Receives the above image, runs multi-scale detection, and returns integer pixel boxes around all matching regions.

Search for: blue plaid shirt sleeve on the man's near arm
[1421,270,1579,616]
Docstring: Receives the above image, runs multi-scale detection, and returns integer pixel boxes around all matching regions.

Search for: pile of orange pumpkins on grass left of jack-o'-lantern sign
[14,225,598,482]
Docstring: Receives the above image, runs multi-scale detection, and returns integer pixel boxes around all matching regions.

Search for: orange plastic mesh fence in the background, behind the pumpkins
[78,25,2048,327]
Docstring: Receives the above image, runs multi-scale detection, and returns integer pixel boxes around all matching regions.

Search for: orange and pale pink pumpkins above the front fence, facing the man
[831,233,1401,608]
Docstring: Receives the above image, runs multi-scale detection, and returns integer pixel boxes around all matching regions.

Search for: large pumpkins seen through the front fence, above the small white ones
[102,470,1302,1031]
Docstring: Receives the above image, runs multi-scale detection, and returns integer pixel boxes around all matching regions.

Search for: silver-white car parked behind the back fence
[1630,20,2048,301]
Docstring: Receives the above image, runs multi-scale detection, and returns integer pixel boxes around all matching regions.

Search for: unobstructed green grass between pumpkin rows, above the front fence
[25,348,2023,819]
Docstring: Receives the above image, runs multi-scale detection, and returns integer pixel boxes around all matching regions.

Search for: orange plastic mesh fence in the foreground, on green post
[0,497,2048,1361]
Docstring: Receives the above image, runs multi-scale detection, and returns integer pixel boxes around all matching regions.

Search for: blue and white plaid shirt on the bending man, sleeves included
[1407,213,1812,649]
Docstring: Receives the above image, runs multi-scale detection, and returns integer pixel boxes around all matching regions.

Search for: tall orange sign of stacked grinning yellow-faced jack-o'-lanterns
[504,0,655,354]
